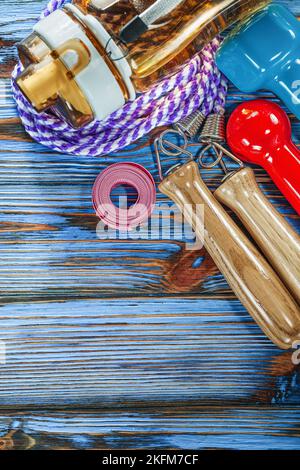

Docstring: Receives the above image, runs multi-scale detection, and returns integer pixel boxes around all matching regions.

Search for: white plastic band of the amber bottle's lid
[34,5,136,121]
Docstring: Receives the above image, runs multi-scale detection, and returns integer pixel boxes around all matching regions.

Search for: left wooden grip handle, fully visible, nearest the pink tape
[159,162,300,349]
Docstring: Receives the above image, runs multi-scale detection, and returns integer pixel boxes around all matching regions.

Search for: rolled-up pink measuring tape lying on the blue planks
[92,162,156,231]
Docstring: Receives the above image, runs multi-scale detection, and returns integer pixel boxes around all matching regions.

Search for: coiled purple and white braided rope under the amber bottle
[12,0,227,157]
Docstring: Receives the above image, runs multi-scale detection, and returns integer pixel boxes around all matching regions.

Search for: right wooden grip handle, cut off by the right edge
[214,168,300,303]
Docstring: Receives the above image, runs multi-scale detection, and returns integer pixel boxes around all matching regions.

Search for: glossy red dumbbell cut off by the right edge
[227,100,300,214]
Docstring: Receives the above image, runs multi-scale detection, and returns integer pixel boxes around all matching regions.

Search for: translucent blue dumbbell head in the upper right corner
[217,4,300,119]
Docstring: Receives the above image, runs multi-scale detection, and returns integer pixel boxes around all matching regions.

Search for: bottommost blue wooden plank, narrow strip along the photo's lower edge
[0,405,300,450]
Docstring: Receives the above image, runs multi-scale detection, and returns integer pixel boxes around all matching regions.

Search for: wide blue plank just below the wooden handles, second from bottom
[0,296,299,408]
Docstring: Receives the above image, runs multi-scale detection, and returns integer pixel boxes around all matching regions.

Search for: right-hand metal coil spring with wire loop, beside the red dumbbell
[198,113,244,177]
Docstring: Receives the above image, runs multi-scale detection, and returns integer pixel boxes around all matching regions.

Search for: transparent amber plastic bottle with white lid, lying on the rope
[17,0,271,127]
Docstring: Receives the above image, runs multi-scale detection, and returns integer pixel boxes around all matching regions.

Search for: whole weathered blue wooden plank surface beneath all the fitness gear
[0,0,300,448]
